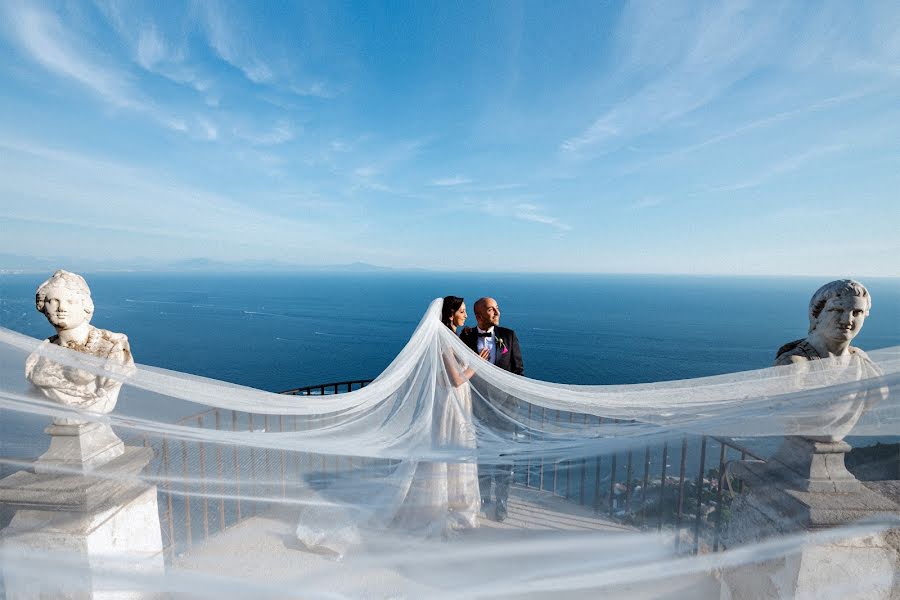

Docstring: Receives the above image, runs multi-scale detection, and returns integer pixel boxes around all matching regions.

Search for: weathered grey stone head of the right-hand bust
[809,279,872,338]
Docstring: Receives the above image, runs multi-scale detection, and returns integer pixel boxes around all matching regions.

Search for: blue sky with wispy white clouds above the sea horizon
[0,0,900,277]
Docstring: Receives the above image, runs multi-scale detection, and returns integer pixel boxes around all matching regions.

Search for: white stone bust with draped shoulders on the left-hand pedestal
[25,270,134,413]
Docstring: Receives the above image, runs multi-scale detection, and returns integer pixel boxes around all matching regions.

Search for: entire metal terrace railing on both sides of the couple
[145,379,759,560]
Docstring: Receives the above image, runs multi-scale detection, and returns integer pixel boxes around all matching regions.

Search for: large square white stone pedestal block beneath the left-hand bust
[0,447,164,600]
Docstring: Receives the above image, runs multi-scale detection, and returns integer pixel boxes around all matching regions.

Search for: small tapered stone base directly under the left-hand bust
[34,423,125,473]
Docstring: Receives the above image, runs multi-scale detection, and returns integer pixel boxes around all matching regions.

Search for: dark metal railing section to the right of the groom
[515,406,762,554]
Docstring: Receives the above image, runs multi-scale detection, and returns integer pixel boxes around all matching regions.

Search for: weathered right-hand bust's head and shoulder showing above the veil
[775,279,872,366]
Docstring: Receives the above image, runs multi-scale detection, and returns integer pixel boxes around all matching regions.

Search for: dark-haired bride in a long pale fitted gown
[394,296,481,533]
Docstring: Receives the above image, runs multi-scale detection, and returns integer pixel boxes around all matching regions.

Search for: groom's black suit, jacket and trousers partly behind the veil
[459,325,525,521]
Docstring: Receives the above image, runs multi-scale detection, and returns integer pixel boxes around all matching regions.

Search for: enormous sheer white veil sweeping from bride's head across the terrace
[0,300,900,598]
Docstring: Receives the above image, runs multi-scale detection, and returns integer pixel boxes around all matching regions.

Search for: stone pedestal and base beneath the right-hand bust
[721,439,900,600]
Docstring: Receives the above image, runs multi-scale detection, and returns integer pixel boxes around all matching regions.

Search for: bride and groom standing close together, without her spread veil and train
[436,296,525,527]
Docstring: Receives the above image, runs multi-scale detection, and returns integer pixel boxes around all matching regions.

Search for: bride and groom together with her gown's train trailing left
[296,296,524,556]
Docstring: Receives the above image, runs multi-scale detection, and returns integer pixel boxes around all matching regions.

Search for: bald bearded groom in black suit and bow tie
[459,298,525,521]
